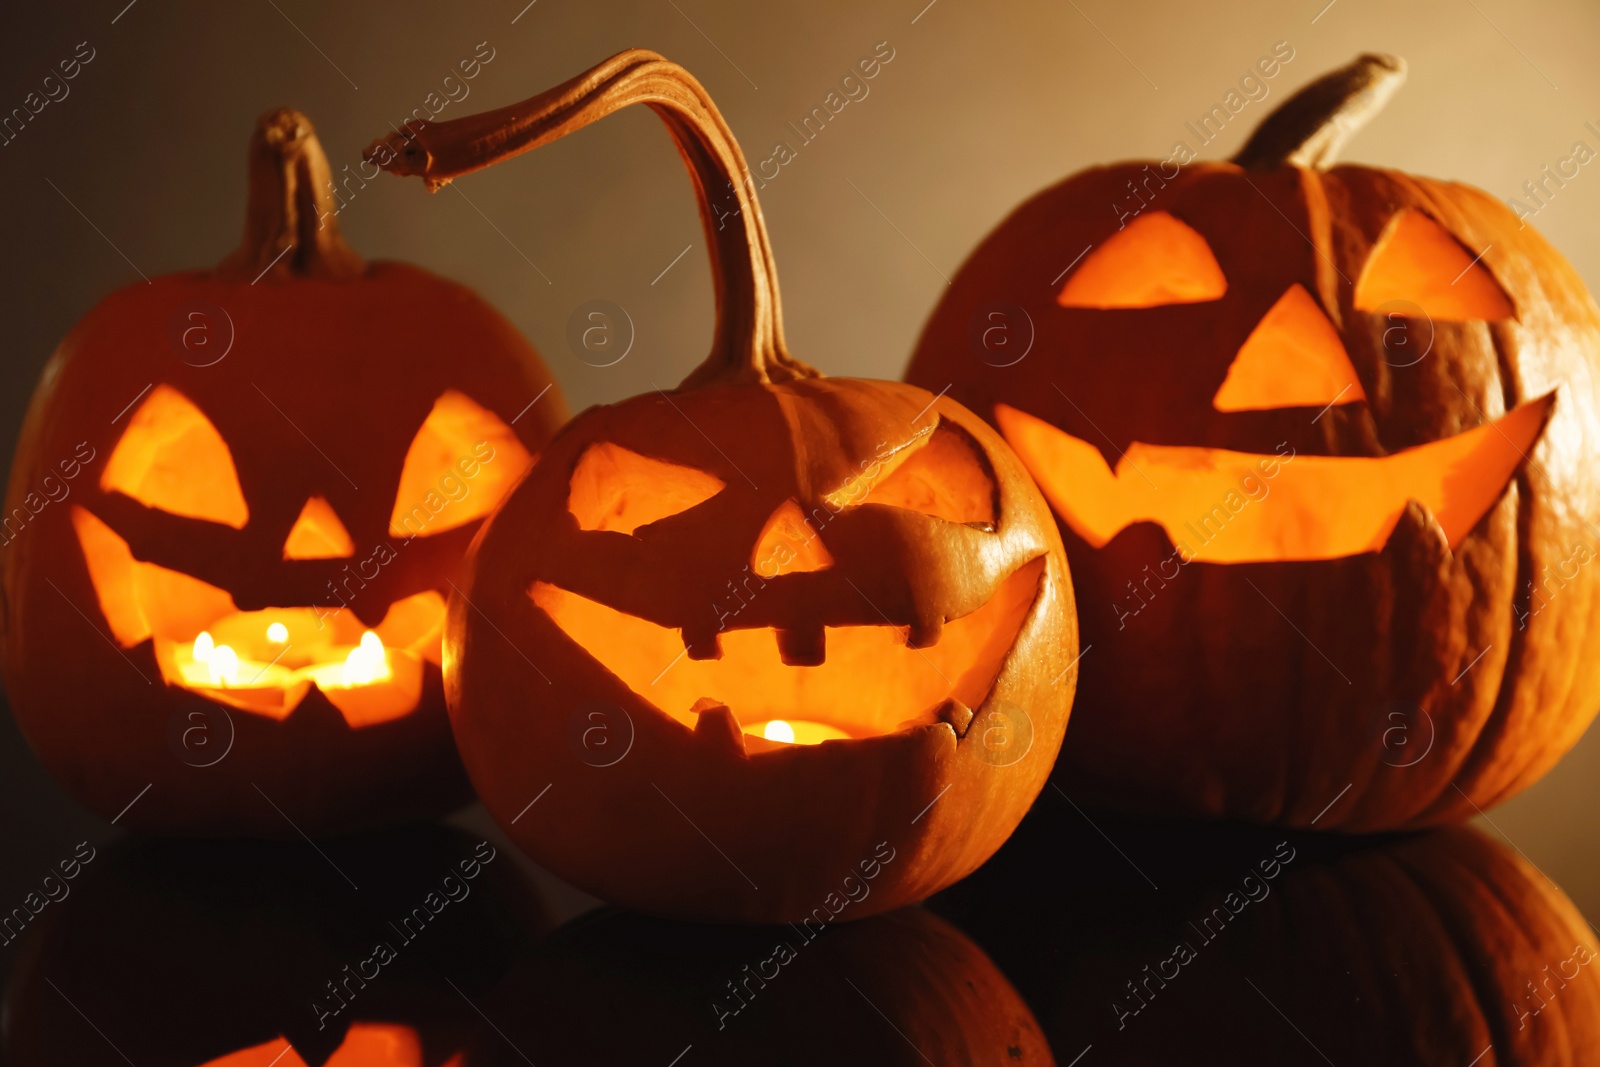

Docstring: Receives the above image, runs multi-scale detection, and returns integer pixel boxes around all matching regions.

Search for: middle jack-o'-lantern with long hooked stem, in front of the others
[370,51,1075,921]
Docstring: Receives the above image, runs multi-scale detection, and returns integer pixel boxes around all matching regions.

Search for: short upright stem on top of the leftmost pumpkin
[218,107,365,282]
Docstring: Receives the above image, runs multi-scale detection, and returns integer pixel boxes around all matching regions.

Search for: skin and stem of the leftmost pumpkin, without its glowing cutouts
[0,112,563,837]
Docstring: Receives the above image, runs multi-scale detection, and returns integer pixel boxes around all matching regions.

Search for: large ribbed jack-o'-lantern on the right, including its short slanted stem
[907,56,1600,830]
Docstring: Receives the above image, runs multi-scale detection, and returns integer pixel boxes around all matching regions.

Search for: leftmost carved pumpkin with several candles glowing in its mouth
[3,110,563,835]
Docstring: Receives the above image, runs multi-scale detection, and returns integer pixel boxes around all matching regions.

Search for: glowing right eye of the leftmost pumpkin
[389,389,533,537]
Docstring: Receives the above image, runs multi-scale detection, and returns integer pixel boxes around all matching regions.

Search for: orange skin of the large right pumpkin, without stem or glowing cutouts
[907,61,1600,832]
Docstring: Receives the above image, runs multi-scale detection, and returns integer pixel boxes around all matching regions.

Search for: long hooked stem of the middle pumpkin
[366,48,818,389]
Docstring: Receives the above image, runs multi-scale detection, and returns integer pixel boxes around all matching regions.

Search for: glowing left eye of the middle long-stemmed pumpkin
[566,442,723,534]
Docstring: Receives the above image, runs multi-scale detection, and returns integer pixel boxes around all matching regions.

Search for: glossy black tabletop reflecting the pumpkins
[0,767,1600,1067]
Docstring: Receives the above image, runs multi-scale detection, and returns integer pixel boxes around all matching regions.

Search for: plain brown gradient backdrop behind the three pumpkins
[0,0,1600,1011]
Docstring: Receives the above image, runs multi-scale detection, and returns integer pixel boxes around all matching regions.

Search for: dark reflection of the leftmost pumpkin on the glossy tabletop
[0,825,549,1067]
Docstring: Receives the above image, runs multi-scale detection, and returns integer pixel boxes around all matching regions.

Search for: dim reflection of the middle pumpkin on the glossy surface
[467,907,1066,1067]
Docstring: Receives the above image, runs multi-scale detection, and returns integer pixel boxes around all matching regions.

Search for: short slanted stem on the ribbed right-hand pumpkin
[1234,53,1405,171]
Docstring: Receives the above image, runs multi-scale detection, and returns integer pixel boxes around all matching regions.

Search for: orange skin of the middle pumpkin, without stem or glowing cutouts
[445,379,1072,921]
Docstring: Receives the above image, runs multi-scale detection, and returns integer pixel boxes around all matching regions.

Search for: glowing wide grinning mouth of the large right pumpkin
[995,394,1555,563]
